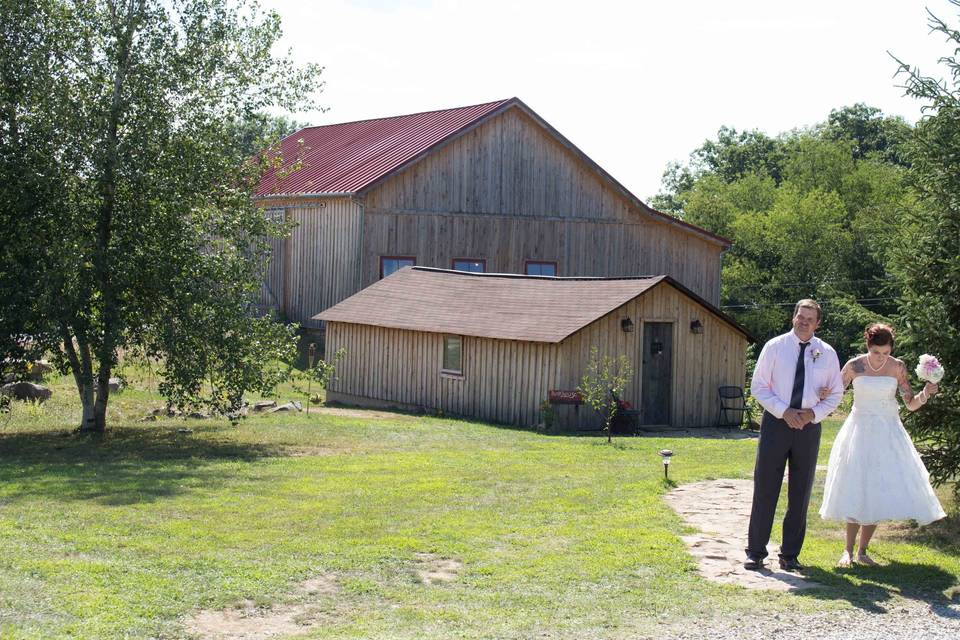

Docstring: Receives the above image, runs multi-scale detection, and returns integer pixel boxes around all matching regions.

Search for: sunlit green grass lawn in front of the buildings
[0,378,960,639]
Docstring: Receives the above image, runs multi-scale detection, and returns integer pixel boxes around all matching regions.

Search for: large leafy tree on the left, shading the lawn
[0,0,319,431]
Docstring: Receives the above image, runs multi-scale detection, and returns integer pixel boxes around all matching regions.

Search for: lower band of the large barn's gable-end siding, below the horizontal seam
[362,208,720,305]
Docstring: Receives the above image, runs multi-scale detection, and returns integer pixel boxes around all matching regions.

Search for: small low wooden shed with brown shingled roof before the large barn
[316,267,751,429]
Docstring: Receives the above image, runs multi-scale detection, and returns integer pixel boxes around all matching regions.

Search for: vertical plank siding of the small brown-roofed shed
[326,285,747,428]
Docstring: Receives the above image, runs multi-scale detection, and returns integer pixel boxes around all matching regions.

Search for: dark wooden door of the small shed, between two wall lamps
[640,322,673,425]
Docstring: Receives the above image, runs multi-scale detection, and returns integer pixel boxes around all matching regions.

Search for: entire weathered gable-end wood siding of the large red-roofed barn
[363,109,721,304]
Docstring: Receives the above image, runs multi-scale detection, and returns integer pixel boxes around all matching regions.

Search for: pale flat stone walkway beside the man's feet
[666,480,818,591]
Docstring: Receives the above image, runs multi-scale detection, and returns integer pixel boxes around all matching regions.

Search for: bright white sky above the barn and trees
[262,0,958,200]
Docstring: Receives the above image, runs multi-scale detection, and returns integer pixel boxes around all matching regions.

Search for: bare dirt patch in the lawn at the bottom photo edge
[184,574,339,640]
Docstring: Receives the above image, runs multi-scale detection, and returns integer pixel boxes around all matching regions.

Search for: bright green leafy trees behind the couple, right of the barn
[654,109,917,355]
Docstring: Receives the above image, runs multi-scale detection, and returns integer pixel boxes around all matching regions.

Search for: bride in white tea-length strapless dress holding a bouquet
[820,323,946,567]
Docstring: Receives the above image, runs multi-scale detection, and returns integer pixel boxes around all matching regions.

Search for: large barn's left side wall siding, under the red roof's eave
[264,198,363,328]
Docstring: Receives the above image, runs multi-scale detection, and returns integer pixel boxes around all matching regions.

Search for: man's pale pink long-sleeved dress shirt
[750,331,843,423]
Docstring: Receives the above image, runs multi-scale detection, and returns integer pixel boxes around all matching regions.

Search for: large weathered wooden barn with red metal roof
[256,98,730,342]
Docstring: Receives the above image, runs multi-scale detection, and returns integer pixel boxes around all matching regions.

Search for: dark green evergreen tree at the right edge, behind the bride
[890,1,960,490]
